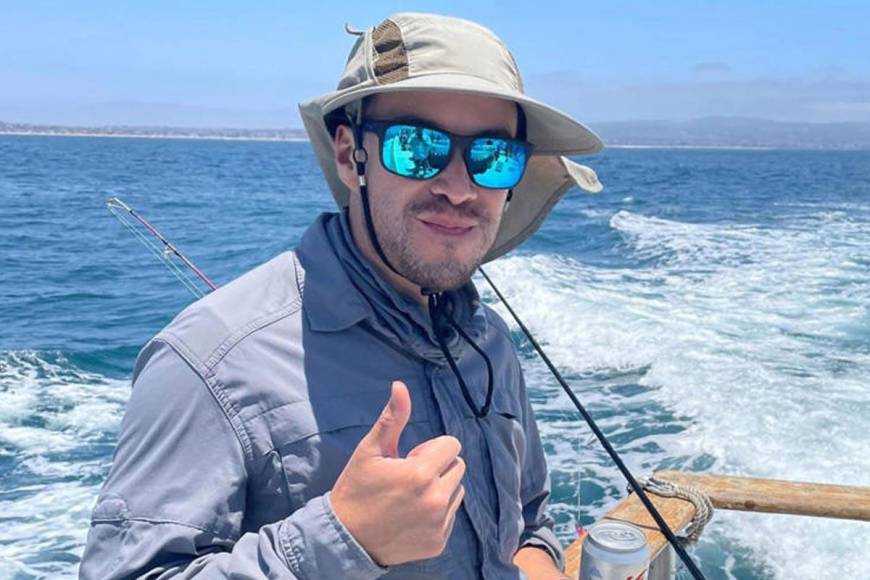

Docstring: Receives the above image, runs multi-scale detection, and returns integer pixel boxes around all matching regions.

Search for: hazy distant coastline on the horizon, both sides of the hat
[0,117,870,151]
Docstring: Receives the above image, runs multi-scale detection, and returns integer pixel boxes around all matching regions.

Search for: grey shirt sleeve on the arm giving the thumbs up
[79,341,387,580]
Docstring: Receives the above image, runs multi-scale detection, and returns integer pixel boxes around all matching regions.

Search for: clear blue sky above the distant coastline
[0,0,870,126]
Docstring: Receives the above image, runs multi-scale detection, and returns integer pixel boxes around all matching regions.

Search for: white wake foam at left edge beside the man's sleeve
[0,352,129,578]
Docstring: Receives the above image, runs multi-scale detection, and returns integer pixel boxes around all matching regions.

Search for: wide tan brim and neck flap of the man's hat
[299,74,604,261]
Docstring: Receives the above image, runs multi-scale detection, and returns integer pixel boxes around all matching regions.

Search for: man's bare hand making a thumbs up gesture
[331,381,465,566]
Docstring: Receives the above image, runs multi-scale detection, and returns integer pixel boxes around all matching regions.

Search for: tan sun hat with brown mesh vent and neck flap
[299,13,603,261]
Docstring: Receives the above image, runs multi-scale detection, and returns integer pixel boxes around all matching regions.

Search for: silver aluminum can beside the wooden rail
[580,522,649,580]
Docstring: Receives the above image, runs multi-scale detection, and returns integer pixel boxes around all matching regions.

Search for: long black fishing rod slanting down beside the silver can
[478,268,706,580]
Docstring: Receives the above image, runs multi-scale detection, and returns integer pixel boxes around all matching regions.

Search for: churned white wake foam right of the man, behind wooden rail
[489,211,870,579]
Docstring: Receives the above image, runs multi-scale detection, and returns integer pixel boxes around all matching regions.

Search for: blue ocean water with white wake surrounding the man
[0,136,870,579]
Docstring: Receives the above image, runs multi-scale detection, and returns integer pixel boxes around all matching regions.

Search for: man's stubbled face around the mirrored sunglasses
[340,91,517,290]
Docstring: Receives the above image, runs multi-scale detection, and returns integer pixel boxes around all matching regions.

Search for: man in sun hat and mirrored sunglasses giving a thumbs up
[81,14,601,579]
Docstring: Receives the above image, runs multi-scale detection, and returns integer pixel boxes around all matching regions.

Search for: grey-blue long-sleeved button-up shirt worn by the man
[80,213,562,580]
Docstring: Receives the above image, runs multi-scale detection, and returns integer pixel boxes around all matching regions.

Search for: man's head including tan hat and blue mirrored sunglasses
[300,13,602,296]
